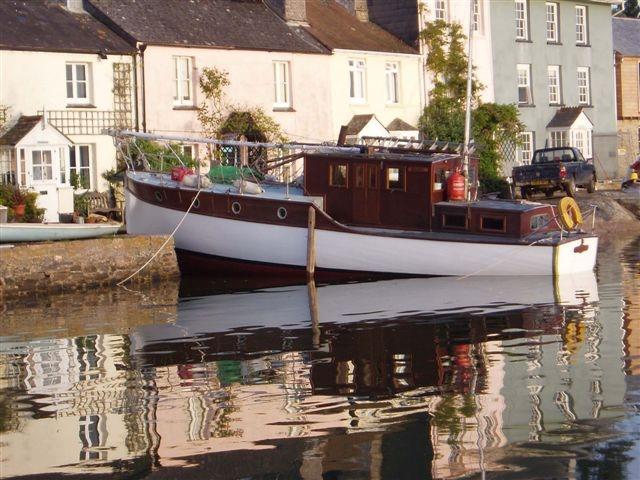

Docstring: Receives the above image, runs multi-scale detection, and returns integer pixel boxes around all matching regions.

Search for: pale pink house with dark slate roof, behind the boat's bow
[87,0,332,154]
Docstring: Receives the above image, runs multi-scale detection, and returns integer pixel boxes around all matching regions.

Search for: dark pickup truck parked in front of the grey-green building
[513,147,596,198]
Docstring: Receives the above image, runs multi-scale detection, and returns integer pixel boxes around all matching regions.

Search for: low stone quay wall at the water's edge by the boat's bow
[0,235,180,301]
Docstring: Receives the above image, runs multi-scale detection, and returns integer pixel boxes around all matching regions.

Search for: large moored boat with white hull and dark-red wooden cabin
[125,133,598,278]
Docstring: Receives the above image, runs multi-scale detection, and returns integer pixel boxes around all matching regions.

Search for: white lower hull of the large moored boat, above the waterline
[126,191,598,276]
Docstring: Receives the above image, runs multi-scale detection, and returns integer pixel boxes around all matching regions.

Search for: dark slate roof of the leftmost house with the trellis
[0,0,134,54]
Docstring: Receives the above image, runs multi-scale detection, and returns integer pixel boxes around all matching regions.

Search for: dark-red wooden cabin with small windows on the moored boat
[304,149,556,237]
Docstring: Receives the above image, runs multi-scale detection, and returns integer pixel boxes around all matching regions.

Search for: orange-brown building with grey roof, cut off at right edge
[613,17,640,165]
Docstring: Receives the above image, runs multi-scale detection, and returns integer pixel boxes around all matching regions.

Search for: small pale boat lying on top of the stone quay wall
[0,223,122,243]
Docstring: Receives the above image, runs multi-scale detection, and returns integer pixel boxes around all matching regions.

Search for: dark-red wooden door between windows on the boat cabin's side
[353,163,380,225]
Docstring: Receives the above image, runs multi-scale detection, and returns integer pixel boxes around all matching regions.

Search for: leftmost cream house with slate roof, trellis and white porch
[0,0,134,221]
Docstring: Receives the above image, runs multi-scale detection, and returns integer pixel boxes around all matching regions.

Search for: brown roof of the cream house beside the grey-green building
[306,0,418,54]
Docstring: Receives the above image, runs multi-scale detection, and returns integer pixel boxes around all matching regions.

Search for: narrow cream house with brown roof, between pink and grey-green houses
[306,0,424,140]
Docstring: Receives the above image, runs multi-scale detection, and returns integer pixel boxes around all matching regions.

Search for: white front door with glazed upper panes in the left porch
[29,148,60,222]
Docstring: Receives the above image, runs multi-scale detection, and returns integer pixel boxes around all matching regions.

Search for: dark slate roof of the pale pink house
[87,0,329,54]
